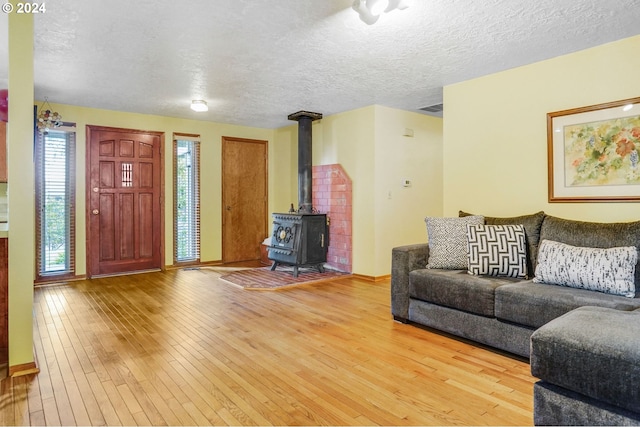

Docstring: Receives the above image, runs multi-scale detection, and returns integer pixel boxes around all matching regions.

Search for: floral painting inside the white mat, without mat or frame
[563,116,640,186]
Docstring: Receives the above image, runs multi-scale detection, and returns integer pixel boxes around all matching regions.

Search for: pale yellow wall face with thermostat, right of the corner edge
[374,106,442,276]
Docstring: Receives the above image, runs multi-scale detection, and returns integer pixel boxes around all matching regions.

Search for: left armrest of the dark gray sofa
[391,243,429,322]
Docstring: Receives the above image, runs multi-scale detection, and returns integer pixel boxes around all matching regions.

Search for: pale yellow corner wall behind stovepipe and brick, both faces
[274,105,442,277]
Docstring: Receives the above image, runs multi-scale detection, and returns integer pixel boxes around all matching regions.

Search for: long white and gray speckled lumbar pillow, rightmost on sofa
[533,240,638,298]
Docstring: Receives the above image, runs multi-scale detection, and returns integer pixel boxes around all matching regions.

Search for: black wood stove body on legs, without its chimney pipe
[268,213,329,277]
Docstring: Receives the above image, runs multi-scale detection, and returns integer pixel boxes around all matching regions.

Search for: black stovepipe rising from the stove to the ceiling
[287,111,322,213]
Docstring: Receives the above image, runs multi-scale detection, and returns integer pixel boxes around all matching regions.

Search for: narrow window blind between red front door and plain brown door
[174,135,200,263]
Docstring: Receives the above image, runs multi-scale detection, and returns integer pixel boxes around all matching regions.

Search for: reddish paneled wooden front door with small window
[87,126,163,277]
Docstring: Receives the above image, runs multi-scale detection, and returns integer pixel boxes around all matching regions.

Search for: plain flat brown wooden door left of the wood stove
[222,137,268,262]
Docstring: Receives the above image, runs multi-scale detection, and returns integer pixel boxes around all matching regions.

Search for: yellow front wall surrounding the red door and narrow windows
[38,102,278,275]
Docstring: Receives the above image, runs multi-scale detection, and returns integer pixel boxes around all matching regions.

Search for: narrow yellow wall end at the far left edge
[7,5,35,367]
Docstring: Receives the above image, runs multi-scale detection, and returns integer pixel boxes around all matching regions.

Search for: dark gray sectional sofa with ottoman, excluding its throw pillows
[391,212,640,425]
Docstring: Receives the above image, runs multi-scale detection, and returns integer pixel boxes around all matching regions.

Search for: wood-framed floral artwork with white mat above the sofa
[547,97,640,202]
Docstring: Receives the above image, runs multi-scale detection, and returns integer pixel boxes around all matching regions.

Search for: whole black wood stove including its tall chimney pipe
[267,111,329,277]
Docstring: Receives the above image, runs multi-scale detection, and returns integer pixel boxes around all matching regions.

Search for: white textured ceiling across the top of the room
[0,0,640,128]
